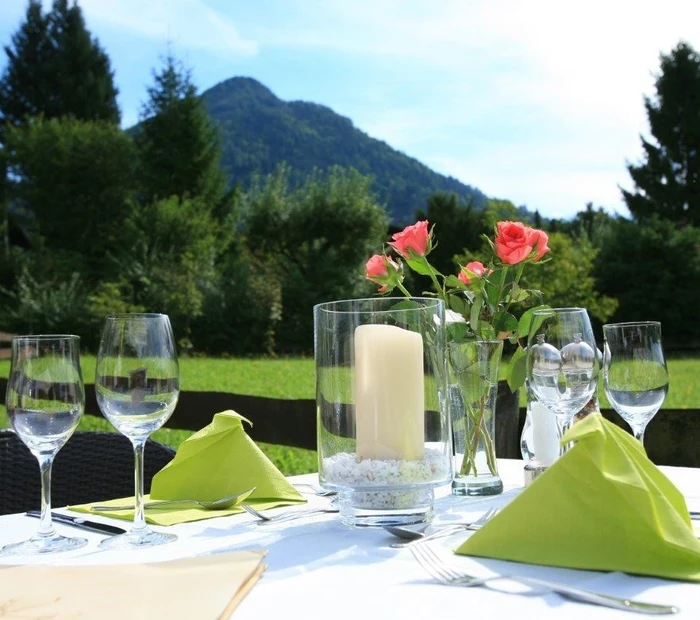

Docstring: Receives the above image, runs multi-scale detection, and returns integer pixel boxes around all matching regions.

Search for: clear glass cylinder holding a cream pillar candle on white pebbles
[314,298,452,526]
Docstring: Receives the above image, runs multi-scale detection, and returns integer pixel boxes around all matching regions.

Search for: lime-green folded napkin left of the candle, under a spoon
[70,411,306,525]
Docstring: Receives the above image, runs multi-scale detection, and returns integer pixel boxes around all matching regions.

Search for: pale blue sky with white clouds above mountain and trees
[0,0,700,217]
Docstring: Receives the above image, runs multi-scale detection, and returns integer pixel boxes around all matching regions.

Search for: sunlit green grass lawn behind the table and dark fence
[0,355,700,475]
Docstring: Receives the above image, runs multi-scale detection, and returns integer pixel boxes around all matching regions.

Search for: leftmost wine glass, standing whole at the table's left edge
[0,335,87,555]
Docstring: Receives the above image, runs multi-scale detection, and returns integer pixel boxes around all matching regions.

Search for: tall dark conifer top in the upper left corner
[0,0,120,126]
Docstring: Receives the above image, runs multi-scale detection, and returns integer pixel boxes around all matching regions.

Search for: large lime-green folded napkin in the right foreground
[455,414,700,581]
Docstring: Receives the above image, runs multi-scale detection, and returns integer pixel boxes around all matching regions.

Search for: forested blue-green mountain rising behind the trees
[202,77,486,225]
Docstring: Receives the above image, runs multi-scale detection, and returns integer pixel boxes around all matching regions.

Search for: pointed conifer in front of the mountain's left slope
[135,55,227,206]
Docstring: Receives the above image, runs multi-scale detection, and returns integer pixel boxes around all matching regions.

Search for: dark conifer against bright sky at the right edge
[622,42,700,226]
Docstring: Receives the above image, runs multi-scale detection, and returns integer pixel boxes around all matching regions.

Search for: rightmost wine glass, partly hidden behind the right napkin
[603,321,668,445]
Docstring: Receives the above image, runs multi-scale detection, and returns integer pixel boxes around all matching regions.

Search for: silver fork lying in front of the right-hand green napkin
[411,545,679,615]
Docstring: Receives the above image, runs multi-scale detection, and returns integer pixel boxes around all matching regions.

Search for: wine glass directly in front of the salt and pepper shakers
[527,308,599,455]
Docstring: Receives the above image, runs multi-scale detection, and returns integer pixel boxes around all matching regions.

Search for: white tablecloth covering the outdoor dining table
[0,460,700,620]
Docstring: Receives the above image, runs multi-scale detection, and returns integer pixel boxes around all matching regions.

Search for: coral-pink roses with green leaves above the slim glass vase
[365,221,549,391]
